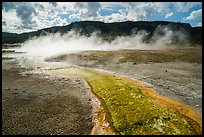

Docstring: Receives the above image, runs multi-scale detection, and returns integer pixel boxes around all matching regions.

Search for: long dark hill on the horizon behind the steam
[2,21,202,45]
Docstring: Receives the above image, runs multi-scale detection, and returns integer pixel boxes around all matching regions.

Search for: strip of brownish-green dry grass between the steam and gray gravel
[47,46,202,65]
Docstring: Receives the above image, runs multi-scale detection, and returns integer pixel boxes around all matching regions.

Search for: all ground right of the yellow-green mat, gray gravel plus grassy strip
[46,45,202,113]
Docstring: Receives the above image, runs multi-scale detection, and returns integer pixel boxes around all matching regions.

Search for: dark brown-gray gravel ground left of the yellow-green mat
[2,59,93,135]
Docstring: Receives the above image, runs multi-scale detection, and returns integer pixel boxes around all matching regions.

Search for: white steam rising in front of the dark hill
[17,26,190,59]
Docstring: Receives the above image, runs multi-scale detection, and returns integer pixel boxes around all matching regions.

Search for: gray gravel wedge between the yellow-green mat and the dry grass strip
[91,62,202,112]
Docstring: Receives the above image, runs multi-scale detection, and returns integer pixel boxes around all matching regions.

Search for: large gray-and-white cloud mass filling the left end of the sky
[2,2,71,33]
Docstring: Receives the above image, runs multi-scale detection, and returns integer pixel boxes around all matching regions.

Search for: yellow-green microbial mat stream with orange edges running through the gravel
[45,66,202,135]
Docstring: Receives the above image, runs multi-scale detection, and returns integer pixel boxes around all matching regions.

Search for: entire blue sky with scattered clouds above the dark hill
[2,2,202,33]
